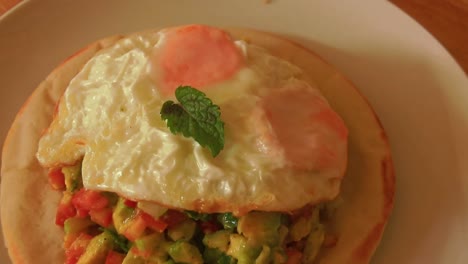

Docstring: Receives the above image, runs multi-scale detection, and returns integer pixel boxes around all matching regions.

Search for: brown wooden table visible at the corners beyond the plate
[0,0,468,74]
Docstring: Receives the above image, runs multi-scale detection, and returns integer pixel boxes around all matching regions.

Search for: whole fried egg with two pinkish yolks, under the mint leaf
[37,25,348,214]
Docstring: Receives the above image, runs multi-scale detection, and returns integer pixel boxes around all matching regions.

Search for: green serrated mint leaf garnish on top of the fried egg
[161,86,224,157]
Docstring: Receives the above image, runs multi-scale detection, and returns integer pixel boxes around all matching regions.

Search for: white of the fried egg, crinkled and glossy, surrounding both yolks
[37,30,346,213]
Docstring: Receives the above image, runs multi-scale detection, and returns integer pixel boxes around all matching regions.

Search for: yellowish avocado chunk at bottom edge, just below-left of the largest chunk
[227,234,262,264]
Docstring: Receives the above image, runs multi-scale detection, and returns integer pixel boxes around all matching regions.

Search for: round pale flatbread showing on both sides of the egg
[0,28,395,263]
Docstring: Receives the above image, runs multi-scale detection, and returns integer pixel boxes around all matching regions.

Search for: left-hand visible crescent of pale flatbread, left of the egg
[0,36,121,264]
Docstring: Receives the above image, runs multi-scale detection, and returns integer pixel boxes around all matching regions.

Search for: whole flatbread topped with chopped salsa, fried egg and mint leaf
[1,25,394,263]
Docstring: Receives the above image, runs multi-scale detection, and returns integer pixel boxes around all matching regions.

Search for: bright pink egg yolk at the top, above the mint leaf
[150,25,245,95]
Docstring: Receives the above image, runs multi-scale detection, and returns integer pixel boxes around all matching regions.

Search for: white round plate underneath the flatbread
[0,0,468,264]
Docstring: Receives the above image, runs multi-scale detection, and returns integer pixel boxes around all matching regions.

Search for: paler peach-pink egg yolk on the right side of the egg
[253,85,348,170]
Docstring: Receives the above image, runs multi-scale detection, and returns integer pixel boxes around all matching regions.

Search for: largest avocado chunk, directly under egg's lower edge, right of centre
[237,211,281,247]
